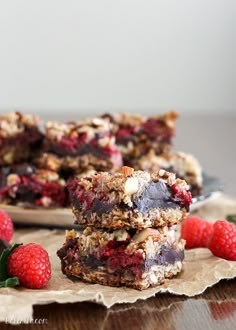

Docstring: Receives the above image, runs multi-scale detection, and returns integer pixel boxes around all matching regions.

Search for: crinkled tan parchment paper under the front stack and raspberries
[0,196,236,322]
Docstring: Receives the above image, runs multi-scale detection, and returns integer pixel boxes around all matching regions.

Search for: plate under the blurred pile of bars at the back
[0,174,222,228]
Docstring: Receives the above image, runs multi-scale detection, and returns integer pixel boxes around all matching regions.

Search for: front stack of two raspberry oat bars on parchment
[57,166,191,290]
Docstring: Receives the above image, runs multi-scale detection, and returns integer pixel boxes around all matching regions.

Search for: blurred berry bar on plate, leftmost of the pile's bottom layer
[0,164,68,207]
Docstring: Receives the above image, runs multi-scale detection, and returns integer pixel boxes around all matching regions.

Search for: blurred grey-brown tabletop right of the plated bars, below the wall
[175,114,236,197]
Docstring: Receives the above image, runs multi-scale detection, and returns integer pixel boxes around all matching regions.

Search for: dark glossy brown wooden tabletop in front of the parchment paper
[0,279,236,330]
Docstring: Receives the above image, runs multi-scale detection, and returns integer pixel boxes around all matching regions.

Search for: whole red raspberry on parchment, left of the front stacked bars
[8,243,51,289]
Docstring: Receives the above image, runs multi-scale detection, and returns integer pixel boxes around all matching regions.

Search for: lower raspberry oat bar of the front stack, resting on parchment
[57,226,184,290]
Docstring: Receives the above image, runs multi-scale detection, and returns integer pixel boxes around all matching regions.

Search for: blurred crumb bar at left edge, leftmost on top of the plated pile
[0,112,43,165]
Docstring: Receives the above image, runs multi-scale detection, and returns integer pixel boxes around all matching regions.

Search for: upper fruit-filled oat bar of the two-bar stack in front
[67,166,191,229]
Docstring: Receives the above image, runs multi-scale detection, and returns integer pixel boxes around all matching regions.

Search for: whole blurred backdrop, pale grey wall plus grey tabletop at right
[0,0,236,195]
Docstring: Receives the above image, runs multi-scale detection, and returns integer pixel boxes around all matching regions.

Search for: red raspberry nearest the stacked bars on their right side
[181,217,212,249]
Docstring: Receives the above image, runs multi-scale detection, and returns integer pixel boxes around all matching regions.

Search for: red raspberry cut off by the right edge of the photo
[208,220,236,261]
